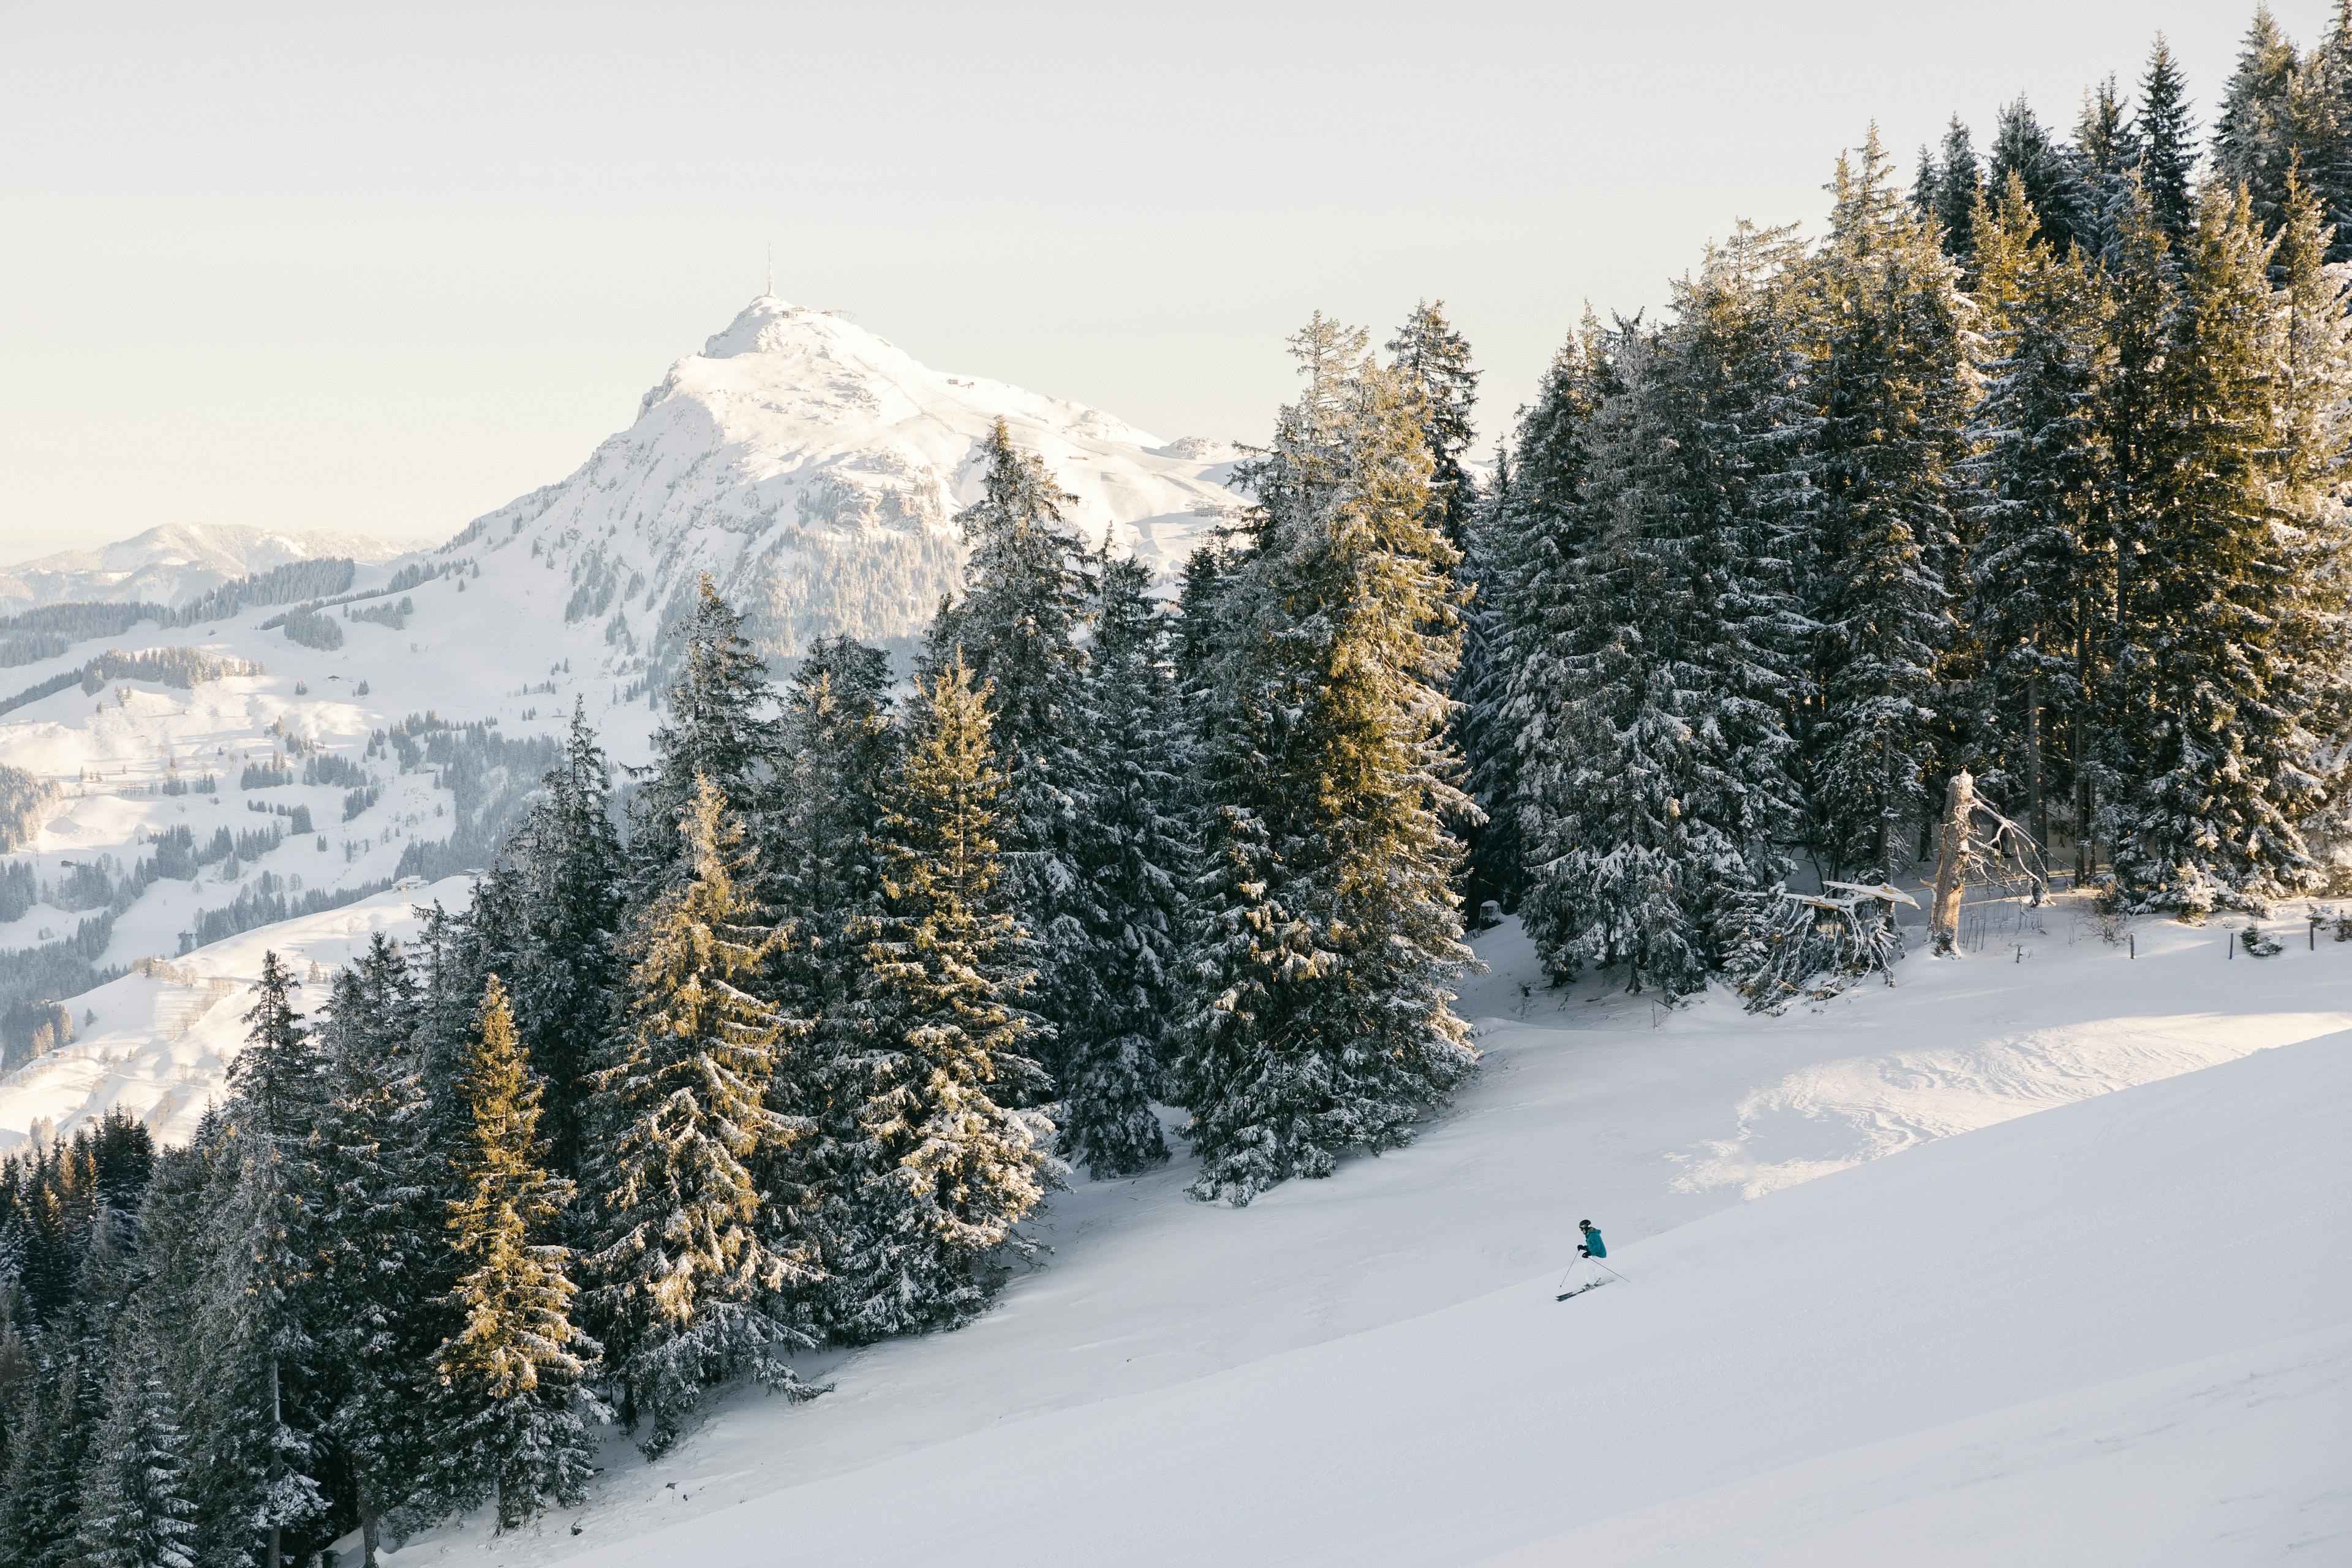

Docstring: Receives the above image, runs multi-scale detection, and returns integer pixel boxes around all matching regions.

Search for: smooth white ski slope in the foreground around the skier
[388,898,2352,1568]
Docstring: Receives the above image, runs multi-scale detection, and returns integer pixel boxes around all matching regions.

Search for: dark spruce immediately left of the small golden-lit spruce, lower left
[311,933,447,1568]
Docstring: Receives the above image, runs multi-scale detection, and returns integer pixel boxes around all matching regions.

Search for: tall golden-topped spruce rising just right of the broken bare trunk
[1964,179,2108,849]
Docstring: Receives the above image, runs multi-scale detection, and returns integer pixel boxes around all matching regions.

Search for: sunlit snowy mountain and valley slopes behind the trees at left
[0,296,1237,1147]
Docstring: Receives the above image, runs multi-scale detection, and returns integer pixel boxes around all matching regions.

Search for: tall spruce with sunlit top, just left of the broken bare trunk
[1801,132,1966,879]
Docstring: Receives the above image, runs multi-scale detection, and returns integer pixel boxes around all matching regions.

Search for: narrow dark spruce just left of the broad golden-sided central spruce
[1061,552,1190,1175]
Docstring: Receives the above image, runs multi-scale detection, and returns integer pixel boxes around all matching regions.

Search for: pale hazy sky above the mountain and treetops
[0,0,2333,562]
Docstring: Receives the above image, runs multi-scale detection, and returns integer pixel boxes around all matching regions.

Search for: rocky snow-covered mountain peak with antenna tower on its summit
[445,294,1235,687]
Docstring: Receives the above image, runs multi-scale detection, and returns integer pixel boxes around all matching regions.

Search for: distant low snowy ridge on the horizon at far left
[0,522,412,616]
